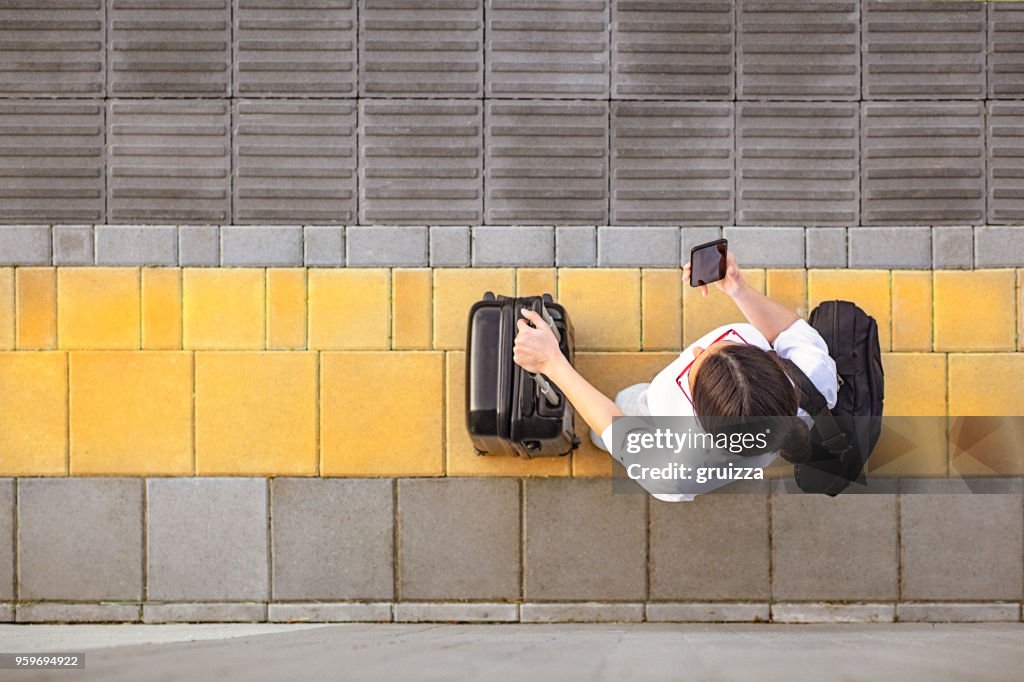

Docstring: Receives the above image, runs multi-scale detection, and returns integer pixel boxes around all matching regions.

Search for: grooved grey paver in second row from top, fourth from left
[359,99,483,224]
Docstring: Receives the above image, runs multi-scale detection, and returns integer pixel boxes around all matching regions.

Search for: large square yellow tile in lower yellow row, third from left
[195,350,317,476]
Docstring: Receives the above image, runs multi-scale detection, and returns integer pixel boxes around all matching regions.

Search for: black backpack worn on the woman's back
[779,301,885,496]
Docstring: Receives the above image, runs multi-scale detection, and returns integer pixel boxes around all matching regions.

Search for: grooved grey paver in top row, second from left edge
[108,0,231,97]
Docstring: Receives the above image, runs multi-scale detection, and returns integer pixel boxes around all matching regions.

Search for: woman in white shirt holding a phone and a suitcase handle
[514,253,839,502]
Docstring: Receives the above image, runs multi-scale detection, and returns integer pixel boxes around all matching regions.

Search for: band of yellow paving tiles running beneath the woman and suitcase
[0,267,1024,476]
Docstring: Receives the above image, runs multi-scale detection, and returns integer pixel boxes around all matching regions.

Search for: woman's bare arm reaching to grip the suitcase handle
[512,310,623,433]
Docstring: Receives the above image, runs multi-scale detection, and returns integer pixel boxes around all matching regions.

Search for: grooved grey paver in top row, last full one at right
[862,0,987,99]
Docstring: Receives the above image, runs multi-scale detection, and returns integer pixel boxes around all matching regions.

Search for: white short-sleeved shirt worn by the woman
[601,319,839,502]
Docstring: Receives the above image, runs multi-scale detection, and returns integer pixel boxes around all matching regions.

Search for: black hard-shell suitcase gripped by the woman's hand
[466,292,580,457]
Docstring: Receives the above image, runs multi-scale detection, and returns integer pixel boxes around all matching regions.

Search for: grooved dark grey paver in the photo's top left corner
[0,0,106,97]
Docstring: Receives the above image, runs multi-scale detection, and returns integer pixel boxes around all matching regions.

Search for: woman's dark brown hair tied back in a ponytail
[693,343,811,462]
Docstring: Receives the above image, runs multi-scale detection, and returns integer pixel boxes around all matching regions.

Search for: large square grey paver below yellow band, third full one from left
[270,477,394,598]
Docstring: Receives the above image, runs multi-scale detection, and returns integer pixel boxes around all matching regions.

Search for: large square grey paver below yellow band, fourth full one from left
[396,478,520,600]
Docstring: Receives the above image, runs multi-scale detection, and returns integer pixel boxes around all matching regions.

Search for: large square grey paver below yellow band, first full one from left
[17,478,142,601]
